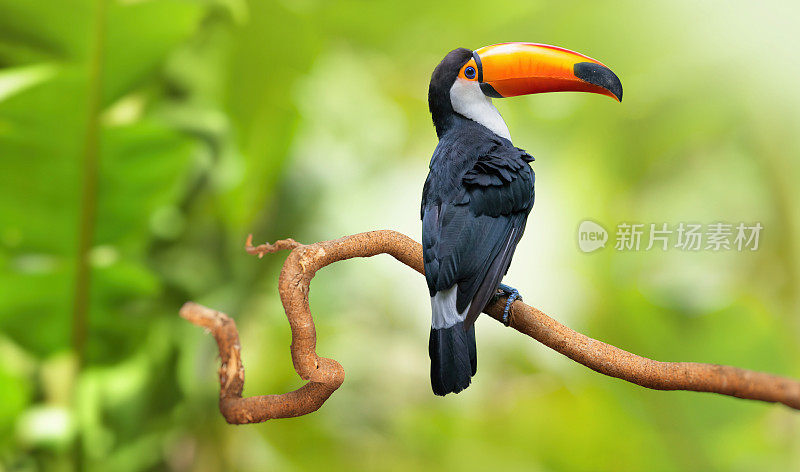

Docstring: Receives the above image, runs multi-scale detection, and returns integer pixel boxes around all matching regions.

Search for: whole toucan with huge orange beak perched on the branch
[421,43,622,395]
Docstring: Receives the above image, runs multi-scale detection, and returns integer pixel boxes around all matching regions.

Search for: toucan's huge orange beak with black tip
[472,43,622,102]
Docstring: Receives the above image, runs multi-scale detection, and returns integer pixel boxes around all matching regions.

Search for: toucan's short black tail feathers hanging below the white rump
[428,322,478,395]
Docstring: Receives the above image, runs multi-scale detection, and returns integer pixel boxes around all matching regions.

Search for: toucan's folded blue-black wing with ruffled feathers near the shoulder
[422,144,534,328]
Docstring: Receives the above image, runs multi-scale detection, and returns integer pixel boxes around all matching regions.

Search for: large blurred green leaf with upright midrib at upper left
[0,1,201,354]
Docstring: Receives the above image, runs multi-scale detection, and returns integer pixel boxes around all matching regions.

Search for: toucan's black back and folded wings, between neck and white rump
[421,117,534,327]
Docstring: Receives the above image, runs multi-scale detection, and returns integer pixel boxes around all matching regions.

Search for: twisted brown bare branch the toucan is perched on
[181,230,800,424]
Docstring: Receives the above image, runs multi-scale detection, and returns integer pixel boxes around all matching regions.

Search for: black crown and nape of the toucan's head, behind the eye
[428,48,472,137]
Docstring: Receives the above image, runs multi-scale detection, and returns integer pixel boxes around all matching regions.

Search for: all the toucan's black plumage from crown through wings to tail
[421,49,534,395]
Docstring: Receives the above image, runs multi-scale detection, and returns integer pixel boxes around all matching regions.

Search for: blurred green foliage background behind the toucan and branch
[0,0,800,471]
